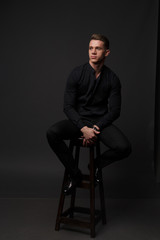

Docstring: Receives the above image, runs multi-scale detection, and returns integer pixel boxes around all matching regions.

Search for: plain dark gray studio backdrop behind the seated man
[0,0,158,197]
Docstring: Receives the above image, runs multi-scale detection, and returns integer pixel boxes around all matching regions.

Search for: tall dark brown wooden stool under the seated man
[55,139,106,237]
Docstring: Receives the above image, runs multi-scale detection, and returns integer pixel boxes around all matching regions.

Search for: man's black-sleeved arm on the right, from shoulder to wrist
[96,75,121,130]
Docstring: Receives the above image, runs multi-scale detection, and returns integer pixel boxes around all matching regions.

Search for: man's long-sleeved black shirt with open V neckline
[64,63,121,129]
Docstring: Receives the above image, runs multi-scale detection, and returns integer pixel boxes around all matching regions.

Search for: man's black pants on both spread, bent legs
[47,120,131,177]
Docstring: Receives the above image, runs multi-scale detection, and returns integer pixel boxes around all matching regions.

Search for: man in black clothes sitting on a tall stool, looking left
[47,34,131,195]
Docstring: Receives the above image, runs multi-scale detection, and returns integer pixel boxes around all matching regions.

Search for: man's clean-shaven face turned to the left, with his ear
[89,40,110,64]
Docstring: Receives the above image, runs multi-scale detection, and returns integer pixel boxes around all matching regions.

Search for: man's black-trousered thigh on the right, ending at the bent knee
[99,124,130,149]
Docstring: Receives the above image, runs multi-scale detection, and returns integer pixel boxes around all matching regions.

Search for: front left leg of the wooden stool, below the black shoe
[55,170,67,231]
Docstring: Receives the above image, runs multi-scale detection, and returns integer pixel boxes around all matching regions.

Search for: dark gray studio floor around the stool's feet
[0,198,160,240]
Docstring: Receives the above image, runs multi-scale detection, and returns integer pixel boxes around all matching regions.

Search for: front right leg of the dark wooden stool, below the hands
[90,146,95,238]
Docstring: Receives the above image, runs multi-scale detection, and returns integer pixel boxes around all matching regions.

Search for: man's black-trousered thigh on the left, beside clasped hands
[48,120,82,140]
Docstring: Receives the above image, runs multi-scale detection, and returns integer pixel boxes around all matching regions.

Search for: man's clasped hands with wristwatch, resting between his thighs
[81,125,100,146]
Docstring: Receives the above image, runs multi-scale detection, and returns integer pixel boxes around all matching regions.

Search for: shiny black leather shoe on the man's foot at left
[63,173,82,195]
